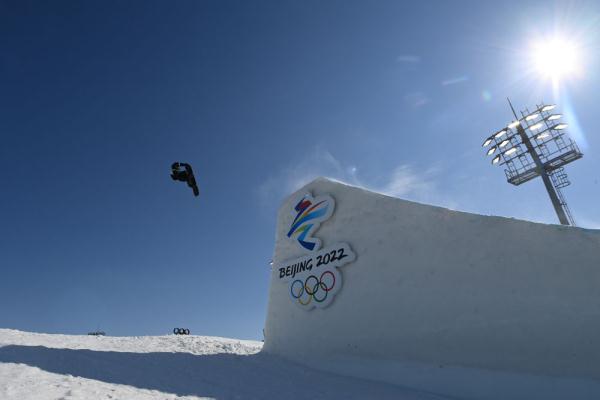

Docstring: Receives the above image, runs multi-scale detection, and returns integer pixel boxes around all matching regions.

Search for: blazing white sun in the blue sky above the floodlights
[532,36,581,81]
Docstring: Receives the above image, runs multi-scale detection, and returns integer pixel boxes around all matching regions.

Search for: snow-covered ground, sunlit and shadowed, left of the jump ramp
[0,329,445,400]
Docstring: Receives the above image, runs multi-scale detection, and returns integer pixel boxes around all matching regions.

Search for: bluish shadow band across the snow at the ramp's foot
[0,345,438,400]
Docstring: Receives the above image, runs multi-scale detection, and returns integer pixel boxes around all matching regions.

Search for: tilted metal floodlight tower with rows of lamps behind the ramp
[483,99,583,226]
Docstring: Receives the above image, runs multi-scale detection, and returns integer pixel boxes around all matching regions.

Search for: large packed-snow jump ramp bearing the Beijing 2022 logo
[263,178,600,399]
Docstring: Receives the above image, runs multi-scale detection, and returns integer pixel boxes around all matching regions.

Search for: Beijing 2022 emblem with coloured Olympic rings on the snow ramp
[275,194,356,310]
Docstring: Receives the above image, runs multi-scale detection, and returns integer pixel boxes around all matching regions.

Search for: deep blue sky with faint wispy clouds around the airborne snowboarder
[0,0,600,339]
